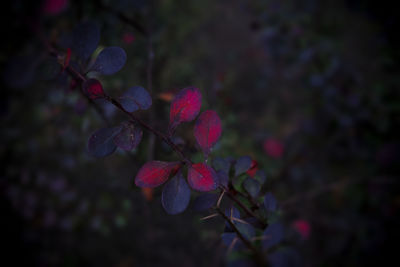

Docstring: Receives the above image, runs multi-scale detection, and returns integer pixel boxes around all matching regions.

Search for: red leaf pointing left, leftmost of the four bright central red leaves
[135,161,180,187]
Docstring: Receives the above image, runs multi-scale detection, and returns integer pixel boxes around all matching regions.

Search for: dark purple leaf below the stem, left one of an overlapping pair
[88,127,121,158]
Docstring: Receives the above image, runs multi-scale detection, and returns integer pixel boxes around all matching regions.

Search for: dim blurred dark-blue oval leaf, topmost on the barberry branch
[71,21,100,60]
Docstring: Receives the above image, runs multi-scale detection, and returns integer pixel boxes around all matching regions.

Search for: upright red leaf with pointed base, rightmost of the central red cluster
[194,110,222,157]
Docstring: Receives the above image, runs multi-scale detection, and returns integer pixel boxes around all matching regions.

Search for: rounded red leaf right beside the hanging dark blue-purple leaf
[188,163,218,192]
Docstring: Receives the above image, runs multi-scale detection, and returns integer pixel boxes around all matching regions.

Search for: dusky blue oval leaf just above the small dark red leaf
[91,46,126,75]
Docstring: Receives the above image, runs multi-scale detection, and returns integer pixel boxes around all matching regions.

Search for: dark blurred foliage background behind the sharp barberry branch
[0,0,400,266]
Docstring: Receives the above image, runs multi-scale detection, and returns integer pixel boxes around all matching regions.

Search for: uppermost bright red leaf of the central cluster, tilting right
[169,87,201,132]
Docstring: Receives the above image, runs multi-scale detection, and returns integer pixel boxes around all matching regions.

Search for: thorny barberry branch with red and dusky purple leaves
[7,17,285,265]
